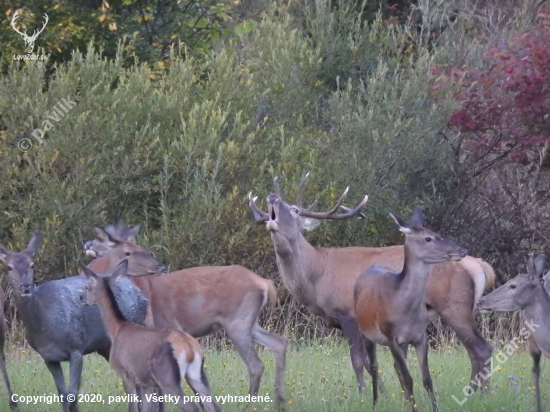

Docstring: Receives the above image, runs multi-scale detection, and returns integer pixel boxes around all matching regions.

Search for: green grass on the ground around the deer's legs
[0,339,550,412]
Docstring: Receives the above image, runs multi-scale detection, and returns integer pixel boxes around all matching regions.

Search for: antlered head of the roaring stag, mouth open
[248,173,369,243]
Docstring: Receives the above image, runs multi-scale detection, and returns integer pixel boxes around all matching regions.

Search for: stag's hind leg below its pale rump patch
[439,312,493,393]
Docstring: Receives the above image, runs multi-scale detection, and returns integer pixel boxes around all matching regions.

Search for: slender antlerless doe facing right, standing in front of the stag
[354,208,466,411]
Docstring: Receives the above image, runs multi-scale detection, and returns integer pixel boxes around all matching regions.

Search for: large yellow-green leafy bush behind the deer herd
[0,3,466,334]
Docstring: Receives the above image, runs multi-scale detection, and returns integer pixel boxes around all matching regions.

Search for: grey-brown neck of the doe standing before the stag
[399,243,430,308]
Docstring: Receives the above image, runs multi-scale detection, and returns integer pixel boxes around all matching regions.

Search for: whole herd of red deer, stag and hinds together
[0,175,550,411]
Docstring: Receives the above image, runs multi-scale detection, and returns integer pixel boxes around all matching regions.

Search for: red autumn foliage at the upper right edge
[448,25,550,164]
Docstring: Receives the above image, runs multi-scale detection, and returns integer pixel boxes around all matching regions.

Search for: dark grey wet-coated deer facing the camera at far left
[0,231,164,412]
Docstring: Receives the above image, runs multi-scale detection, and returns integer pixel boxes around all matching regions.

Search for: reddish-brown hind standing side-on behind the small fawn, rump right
[86,224,288,403]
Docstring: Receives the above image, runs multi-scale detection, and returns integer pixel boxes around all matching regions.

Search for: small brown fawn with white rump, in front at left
[82,260,219,412]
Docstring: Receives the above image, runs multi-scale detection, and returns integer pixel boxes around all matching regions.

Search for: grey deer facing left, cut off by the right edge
[479,255,550,412]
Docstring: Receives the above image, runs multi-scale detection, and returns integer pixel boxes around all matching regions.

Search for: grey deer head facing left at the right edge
[478,255,546,312]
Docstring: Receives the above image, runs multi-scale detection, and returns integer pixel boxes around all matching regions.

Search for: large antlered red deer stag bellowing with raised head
[249,174,495,391]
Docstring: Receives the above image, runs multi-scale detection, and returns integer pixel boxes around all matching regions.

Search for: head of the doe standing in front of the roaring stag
[390,207,467,264]
